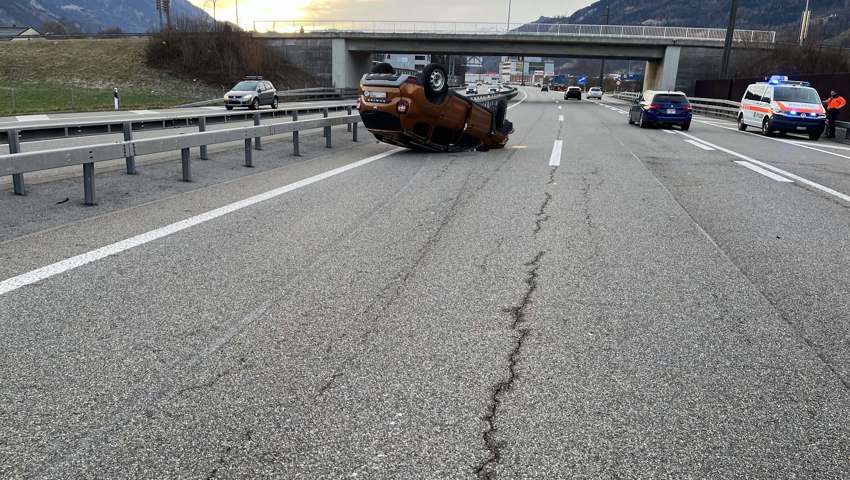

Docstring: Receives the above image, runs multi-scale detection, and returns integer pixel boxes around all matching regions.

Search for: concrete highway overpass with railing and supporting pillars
[255,22,775,90]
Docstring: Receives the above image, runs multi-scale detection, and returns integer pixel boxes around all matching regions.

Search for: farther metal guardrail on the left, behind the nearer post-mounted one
[0,101,356,143]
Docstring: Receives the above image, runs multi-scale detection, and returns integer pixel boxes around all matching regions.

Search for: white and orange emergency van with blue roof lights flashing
[738,76,826,140]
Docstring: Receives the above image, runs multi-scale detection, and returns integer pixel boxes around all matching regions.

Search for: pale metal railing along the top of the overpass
[254,20,776,43]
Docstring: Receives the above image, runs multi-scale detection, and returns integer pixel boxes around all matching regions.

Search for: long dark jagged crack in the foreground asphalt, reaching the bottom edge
[475,250,546,480]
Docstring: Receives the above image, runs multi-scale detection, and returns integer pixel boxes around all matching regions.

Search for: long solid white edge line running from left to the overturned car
[0,148,404,295]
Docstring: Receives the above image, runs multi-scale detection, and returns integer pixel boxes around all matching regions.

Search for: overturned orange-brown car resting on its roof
[358,63,513,152]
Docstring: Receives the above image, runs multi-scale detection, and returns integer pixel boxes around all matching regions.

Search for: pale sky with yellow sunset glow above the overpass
[189,0,593,28]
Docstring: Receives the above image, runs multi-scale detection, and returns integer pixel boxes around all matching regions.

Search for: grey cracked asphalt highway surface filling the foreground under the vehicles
[0,89,850,479]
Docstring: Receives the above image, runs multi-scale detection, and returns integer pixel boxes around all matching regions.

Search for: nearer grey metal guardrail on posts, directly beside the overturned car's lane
[0,112,360,205]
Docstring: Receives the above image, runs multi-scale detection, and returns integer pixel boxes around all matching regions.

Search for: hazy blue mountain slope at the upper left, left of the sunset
[0,0,207,33]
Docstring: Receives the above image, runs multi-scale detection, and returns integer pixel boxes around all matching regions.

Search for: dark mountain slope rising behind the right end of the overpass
[535,0,850,43]
